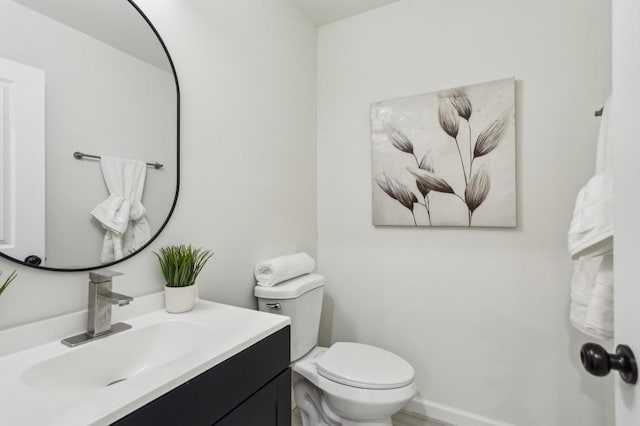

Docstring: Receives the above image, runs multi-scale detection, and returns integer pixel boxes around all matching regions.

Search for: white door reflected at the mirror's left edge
[0,58,45,260]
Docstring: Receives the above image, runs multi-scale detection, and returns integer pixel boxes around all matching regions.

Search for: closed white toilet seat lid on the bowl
[316,342,415,389]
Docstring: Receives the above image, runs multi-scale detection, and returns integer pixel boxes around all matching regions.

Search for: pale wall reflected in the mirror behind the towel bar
[0,0,176,267]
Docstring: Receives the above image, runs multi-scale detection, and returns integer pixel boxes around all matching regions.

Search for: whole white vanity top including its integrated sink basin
[0,295,289,426]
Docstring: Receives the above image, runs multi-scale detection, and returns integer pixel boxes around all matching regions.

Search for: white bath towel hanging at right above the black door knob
[568,101,613,339]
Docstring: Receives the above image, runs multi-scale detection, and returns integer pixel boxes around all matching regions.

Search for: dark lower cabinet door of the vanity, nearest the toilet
[216,370,291,426]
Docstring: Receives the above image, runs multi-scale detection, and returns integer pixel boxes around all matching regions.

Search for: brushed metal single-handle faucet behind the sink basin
[62,269,133,347]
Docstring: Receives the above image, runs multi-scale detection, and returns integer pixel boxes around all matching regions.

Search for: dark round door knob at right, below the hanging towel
[580,343,638,385]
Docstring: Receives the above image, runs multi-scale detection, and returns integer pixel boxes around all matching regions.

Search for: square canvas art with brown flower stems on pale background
[371,78,516,227]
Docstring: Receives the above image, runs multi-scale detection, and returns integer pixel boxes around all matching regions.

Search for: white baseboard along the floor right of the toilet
[404,396,513,426]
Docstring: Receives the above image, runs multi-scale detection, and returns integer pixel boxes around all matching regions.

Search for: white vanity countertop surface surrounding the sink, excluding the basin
[0,300,290,426]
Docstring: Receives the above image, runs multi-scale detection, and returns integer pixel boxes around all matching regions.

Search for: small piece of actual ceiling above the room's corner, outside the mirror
[294,0,398,27]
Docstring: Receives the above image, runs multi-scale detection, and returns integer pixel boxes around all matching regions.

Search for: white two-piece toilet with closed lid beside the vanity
[254,274,417,426]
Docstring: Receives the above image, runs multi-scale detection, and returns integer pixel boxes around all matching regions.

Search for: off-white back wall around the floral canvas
[318,0,612,426]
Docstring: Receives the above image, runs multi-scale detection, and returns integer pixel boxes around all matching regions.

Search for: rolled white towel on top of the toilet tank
[254,252,316,287]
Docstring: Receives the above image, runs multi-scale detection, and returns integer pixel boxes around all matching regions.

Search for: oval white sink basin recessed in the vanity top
[22,321,214,394]
